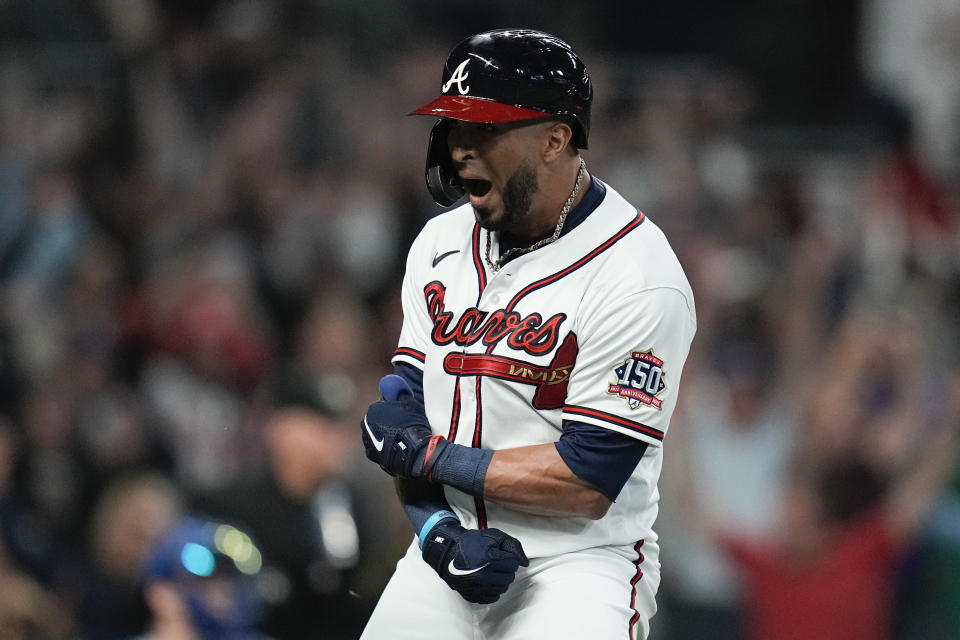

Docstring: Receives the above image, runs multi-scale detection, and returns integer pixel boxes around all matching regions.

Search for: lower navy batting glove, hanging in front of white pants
[421,519,530,604]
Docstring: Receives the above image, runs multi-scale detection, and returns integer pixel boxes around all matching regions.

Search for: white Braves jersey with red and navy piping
[393,178,696,562]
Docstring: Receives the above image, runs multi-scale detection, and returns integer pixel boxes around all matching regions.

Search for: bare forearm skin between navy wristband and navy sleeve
[483,443,612,519]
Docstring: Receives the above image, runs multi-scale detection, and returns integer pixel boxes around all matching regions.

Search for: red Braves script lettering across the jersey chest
[423,281,567,355]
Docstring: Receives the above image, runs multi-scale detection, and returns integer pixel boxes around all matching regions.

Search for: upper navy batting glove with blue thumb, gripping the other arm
[360,375,446,478]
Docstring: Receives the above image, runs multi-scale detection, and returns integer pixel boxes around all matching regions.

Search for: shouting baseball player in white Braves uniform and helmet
[361,30,696,640]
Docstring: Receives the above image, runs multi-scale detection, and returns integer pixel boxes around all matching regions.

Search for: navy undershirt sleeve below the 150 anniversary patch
[557,420,647,500]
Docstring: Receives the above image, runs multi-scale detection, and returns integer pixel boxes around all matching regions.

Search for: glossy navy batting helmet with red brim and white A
[411,29,593,206]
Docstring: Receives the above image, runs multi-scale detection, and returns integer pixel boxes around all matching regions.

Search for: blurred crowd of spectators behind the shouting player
[0,0,960,640]
